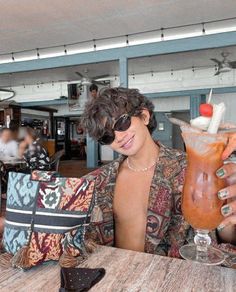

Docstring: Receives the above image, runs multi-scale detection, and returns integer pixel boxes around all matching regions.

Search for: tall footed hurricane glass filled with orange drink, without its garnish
[180,129,227,265]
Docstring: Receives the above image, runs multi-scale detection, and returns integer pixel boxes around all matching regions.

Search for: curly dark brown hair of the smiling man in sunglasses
[81,87,157,140]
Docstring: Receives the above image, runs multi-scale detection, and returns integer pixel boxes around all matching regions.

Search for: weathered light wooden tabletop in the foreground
[0,247,236,292]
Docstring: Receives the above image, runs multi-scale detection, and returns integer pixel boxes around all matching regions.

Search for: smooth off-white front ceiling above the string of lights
[0,0,236,53]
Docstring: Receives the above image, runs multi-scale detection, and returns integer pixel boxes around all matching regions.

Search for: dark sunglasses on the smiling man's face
[98,114,132,145]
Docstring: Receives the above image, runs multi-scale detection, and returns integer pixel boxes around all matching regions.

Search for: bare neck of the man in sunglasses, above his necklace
[128,136,159,168]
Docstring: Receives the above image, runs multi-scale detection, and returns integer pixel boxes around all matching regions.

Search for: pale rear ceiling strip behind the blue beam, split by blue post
[0,46,236,87]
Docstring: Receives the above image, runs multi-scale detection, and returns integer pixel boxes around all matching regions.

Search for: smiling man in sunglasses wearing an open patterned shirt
[83,88,236,257]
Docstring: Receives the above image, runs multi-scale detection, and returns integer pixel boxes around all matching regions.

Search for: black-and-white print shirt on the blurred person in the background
[23,140,50,170]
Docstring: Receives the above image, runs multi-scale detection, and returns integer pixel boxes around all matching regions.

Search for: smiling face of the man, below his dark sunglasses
[110,115,150,156]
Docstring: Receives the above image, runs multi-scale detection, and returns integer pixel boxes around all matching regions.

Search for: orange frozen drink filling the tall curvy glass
[182,133,227,230]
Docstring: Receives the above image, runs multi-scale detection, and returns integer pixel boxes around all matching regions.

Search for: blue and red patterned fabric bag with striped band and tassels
[3,171,94,269]
